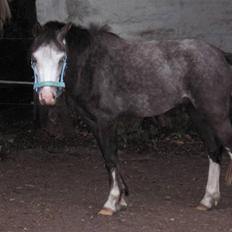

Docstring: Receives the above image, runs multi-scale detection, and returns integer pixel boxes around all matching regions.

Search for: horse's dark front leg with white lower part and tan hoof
[95,122,128,216]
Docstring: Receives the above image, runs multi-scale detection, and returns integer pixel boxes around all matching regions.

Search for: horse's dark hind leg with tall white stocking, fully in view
[188,106,223,210]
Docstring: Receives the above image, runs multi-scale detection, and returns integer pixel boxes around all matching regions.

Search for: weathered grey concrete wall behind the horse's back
[37,0,232,51]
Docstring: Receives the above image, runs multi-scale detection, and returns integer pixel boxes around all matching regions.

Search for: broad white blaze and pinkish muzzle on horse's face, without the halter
[32,44,65,105]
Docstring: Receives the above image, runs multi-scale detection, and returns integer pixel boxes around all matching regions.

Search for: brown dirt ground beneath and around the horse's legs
[0,109,232,232]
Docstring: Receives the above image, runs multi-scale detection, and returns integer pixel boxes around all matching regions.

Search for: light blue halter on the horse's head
[31,56,67,93]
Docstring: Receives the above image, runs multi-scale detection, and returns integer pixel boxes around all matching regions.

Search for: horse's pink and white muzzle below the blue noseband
[39,87,56,106]
